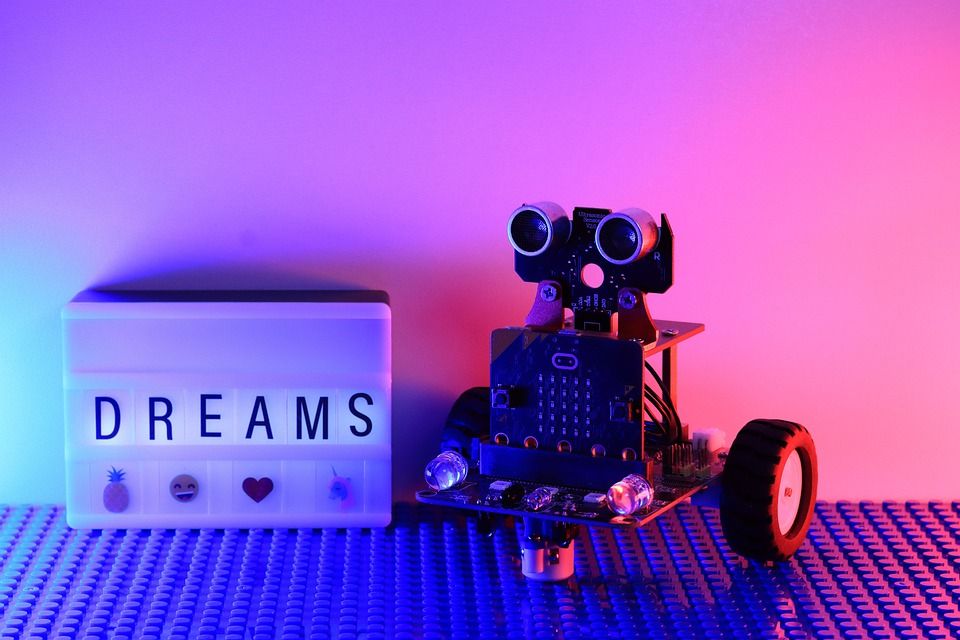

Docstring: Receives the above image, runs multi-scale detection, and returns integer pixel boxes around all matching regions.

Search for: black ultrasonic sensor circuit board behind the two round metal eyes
[514,207,673,331]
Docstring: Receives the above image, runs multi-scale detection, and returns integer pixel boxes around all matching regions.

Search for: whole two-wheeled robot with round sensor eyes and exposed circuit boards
[417,202,817,581]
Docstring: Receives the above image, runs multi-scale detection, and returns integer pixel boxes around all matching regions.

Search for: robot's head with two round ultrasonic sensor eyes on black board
[507,202,673,331]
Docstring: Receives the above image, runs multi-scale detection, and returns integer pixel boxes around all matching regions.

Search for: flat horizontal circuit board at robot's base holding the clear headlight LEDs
[417,460,723,528]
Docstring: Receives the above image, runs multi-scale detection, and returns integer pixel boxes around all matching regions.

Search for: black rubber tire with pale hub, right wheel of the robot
[720,420,817,561]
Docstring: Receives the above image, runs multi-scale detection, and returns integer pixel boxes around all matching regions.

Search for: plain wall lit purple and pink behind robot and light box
[0,2,960,502]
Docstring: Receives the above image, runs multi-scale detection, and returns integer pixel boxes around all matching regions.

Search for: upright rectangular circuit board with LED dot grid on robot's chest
[490,328,644,459]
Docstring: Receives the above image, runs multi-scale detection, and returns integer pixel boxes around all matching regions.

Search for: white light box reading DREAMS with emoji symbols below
[63,291,391,528]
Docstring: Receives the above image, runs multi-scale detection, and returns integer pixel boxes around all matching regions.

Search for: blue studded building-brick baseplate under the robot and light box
[0,502,960,640]
